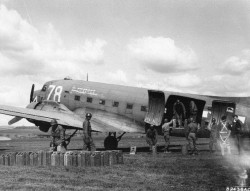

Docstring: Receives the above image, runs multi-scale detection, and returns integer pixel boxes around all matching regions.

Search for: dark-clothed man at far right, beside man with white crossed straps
[232,115,243,154]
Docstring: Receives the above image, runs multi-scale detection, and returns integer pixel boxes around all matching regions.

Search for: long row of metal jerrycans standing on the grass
[0,150,123,167]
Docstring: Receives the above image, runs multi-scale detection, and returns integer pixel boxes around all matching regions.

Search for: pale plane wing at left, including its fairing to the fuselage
[0,105,145,133]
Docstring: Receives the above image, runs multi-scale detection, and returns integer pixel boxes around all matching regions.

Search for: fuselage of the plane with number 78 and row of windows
[34,80,250,137]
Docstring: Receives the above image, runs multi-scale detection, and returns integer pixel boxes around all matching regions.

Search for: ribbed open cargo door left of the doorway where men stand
[144,90,165,126]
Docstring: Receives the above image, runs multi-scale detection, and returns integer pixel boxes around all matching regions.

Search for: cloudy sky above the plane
[0,0,250,124]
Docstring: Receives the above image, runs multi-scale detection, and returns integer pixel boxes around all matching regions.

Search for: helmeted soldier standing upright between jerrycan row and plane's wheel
[83,113,96,151]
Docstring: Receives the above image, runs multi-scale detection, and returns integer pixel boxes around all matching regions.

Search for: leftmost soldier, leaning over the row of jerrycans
[50,119,66,152]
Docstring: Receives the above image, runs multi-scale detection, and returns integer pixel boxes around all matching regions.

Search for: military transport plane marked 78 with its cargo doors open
[0,78,250,149]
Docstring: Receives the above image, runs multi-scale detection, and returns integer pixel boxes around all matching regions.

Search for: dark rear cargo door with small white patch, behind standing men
[212,100,235,123]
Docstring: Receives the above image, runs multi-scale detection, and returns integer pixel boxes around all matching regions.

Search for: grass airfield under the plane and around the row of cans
[0,126,250,191]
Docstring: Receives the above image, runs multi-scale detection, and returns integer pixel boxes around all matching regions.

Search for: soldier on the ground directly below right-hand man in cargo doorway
[188,118,198,155]
